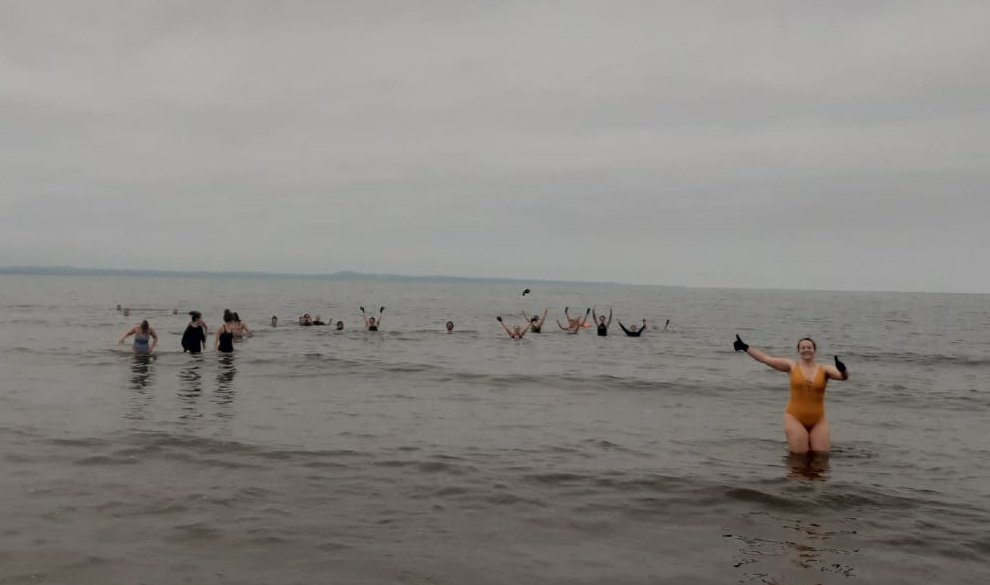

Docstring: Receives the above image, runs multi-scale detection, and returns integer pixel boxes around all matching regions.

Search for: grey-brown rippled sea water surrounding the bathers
[0,275,990,585]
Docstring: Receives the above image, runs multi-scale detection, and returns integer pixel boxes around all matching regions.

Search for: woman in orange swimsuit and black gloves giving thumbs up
[732,335,849,453]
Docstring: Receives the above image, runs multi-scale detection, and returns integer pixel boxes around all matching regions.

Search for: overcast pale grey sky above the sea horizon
[0,0,990,292]
